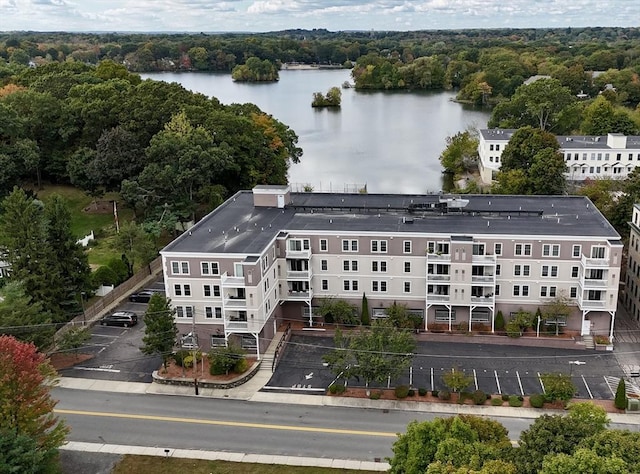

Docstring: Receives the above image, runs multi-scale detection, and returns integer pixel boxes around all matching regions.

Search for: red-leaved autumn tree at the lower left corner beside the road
[0,336,68,473]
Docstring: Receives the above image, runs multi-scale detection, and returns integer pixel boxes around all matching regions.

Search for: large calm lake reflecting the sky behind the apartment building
[141,70,490,194]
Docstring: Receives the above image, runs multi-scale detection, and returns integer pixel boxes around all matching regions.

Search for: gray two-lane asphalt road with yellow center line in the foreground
[52,388,638,461]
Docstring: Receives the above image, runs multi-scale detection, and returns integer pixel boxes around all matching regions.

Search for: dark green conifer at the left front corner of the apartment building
[140,293,178,370]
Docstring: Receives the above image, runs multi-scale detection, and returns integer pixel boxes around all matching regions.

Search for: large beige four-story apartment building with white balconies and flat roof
[161,186,622,355]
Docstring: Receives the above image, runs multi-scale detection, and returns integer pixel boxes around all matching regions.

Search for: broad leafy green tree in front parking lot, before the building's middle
[323,320,415,389]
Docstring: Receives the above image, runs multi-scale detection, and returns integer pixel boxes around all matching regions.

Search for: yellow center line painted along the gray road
[54,409,397,438]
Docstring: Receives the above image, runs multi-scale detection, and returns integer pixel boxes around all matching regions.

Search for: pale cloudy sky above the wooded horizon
[0,0,640,33]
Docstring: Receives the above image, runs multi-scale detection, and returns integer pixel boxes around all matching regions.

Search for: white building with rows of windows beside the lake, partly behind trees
[478,128,640,184]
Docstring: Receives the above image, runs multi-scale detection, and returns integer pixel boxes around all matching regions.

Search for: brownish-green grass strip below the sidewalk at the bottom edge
[112,455,375,474]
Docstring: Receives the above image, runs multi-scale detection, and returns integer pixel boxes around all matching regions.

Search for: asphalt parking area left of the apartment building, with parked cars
[59,281,162,382]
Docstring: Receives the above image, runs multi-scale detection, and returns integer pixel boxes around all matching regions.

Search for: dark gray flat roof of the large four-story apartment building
[163,191,620,254]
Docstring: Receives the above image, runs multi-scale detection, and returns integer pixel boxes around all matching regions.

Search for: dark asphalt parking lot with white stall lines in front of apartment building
[266,335,622,399]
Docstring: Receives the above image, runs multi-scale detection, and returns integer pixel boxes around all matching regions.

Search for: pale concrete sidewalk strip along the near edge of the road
[60,441,389,472]
